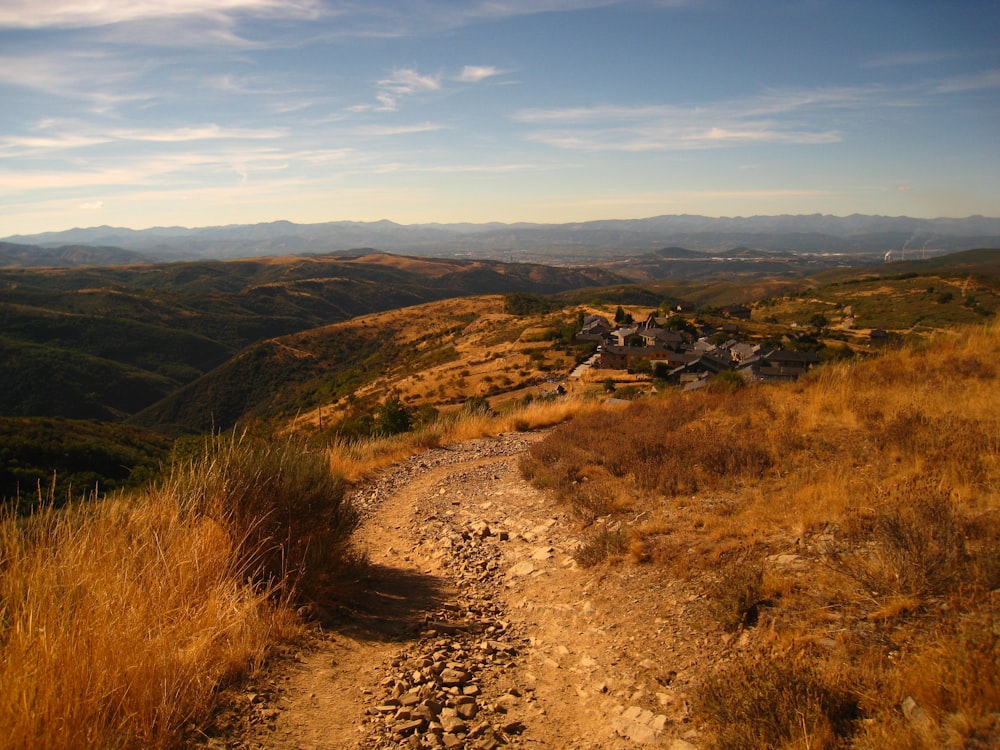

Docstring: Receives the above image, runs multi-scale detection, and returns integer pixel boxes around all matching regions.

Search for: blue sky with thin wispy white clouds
[0,0,1000,236]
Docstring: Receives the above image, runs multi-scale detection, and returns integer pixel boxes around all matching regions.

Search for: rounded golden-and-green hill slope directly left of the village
[134,295,575,431]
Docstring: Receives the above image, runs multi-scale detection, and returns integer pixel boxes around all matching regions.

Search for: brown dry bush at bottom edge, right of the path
[696,655,859,750]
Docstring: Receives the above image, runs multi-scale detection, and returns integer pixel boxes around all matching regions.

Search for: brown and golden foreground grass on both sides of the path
[0,318,1000,750]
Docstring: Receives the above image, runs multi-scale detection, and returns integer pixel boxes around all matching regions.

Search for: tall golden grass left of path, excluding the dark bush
[0,496,293,749]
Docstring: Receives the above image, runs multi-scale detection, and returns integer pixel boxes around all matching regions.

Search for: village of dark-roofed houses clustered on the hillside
[576,313,819,389]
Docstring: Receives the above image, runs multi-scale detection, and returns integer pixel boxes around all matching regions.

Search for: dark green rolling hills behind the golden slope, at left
[0,253,620,420]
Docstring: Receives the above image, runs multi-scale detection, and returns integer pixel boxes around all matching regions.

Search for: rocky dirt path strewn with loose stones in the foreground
[215,433,705,750]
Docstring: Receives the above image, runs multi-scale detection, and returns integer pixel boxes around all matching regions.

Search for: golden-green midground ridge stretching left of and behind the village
[134,254,1000,431]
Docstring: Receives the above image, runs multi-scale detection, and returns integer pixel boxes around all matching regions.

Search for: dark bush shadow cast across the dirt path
[324,563,446,641]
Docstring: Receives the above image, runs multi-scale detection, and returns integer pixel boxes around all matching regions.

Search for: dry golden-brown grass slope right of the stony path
[522,326,1000,748]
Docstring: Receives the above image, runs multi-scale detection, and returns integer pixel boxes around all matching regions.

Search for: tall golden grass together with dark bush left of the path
[0,438,352,750]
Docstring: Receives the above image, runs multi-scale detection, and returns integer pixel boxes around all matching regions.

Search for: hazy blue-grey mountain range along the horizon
[0,214,1000,265]
